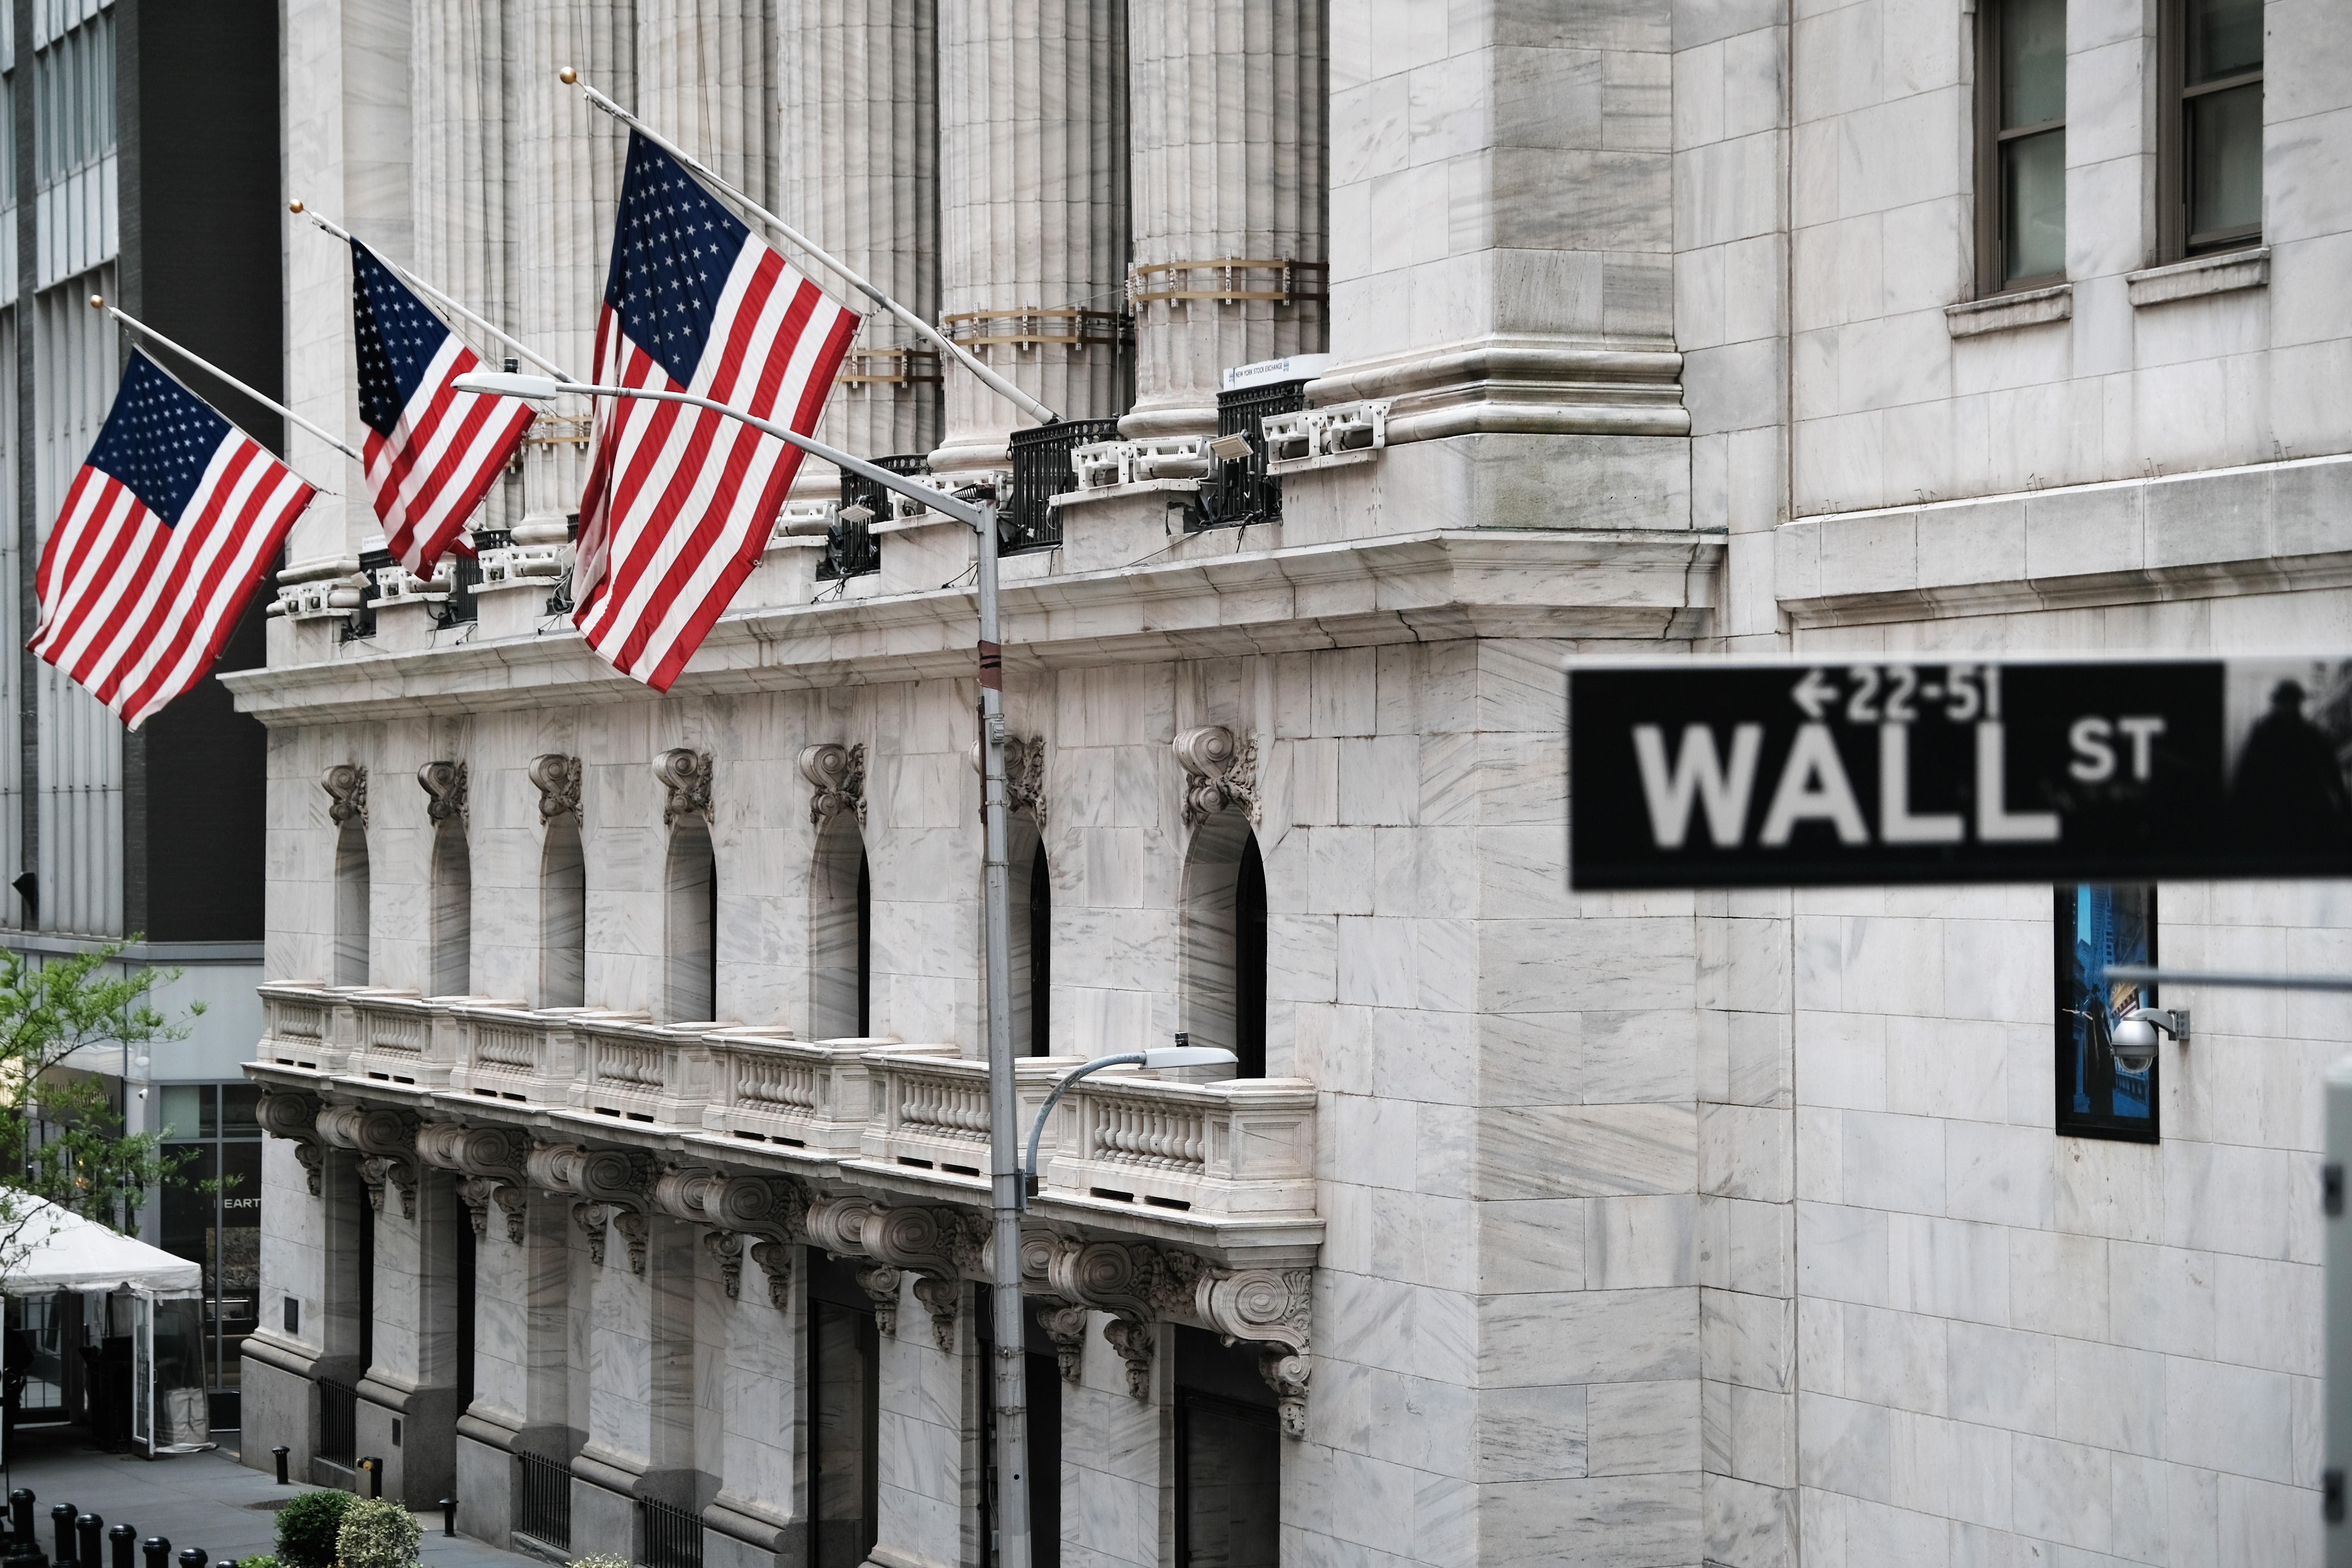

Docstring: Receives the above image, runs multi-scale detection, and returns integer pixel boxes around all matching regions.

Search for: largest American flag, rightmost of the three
[571,132,859,691]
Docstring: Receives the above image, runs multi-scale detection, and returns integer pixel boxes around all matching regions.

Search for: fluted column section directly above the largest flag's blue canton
[637,0,776,205]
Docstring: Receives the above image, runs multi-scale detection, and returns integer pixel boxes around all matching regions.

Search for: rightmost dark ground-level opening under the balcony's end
[1171,1326,1282,1568]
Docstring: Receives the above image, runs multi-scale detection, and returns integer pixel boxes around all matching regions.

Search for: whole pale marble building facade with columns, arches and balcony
[228,0,2352,1568]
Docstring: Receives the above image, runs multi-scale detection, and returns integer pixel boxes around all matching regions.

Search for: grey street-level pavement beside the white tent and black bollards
[7,1429,546,1568]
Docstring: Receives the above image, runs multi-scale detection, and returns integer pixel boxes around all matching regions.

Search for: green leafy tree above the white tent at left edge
[0,943,202,1274]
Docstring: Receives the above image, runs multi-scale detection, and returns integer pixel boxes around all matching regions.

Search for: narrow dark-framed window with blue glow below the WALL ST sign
[2051,886,2159,1142]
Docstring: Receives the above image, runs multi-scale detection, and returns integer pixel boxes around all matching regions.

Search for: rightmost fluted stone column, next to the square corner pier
[1122,0,1329,435]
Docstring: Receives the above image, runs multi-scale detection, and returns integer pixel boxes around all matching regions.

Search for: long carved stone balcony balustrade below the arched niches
[256,985,1315,1222]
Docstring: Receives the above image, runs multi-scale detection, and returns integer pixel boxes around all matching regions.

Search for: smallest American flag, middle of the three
[351,240,531,576]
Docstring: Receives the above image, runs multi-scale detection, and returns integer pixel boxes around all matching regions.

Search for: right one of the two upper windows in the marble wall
[2159,0,2263,256]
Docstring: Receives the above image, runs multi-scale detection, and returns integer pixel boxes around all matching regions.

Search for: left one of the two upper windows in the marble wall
[1978,0,2065,294]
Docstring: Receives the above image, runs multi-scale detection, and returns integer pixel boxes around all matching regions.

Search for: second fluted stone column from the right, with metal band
[931,0,1131,470]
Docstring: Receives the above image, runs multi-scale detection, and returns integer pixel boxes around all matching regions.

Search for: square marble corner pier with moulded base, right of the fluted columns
[1284,0,1691,529]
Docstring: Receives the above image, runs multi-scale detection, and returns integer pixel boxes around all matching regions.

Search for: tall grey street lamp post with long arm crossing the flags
[454,371,1030,1568]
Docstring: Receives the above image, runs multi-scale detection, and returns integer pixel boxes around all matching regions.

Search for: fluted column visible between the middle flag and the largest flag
[510,0,637,543]
